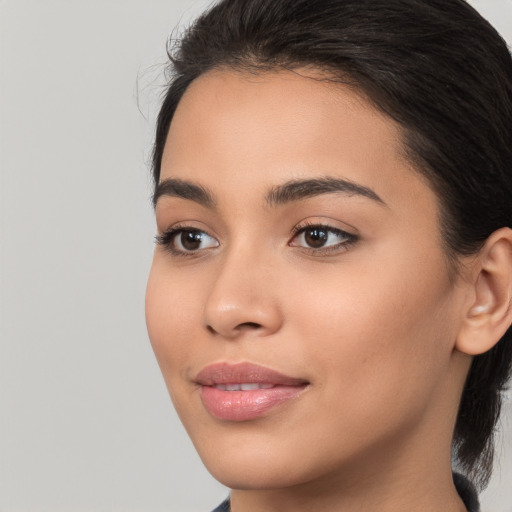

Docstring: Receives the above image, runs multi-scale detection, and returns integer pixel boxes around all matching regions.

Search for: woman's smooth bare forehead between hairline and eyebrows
[161,70,436,212]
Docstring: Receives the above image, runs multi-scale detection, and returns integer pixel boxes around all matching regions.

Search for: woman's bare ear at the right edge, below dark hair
[455,228,512,356]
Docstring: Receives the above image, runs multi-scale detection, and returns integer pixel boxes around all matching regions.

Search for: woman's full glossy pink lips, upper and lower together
[195,363,309,421]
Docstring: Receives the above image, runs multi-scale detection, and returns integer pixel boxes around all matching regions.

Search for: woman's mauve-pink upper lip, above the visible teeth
[195,362,308,386]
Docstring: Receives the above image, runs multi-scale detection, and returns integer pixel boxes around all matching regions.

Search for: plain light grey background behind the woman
[0,0,512,512]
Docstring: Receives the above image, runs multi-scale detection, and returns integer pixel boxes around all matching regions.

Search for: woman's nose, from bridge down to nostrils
[204,245,283,339]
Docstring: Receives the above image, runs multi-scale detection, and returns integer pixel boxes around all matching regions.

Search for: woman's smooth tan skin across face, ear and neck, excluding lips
[146,70,512,512]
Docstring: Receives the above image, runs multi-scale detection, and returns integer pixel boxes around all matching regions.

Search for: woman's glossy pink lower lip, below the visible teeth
[201,385,306,421]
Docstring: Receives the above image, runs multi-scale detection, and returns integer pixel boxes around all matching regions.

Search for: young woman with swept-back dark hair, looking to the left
[146,0,512,512]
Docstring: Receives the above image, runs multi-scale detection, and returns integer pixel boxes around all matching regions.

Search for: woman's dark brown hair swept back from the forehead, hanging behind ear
[153,0,512,487]
